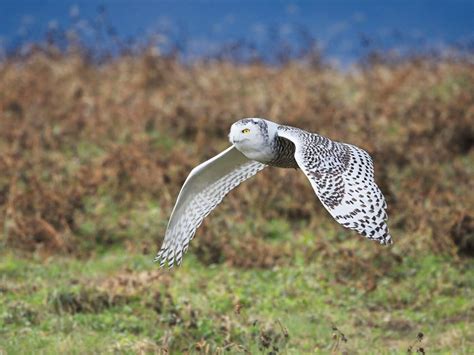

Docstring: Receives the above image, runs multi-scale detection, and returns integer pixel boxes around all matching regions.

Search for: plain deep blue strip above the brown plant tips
[0,0,474,60]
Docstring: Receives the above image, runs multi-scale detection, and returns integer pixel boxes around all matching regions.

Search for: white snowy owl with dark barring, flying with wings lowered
[154,118,392,267]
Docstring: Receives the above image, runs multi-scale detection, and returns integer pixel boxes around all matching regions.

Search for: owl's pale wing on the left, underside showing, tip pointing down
[154,146,266,267]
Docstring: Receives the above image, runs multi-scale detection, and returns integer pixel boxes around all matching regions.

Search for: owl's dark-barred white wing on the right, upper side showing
[278,126,392,244]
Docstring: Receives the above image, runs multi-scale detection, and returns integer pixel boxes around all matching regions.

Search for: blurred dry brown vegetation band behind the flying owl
[0,51,474,267]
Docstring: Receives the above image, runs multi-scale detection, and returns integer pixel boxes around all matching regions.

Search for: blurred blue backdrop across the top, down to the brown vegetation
[0,0,474,66]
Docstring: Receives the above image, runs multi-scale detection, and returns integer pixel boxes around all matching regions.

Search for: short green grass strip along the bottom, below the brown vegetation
[0,249,474,354]
